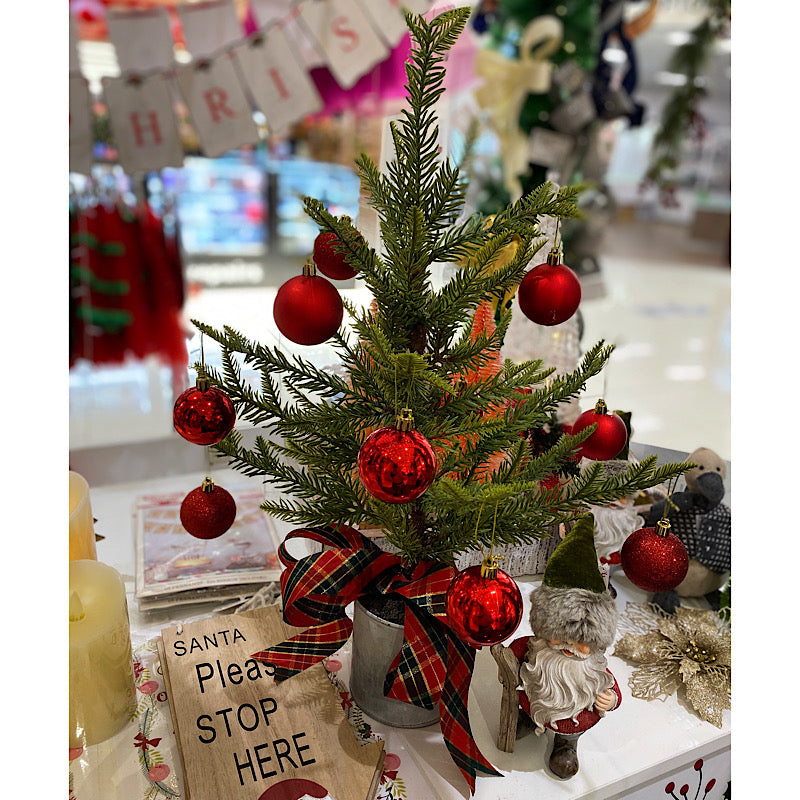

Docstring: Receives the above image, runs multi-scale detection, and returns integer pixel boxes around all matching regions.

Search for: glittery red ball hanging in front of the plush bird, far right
[620,528,689,592]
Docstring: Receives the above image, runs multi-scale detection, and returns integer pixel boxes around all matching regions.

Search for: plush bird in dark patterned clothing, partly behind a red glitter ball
[646,447,731,613]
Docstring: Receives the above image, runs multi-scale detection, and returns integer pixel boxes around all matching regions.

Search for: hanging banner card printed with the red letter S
[297,0,389,89]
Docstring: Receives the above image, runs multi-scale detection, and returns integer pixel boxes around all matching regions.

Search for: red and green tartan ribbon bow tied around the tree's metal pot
[251,526,501,793]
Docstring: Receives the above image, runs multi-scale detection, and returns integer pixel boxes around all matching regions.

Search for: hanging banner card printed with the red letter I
[231,25,323,133]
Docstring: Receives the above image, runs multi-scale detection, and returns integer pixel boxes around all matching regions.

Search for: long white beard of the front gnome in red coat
[520,636,614,734]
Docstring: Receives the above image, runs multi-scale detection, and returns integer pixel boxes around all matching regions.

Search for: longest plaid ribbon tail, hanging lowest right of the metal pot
[439,634,502,794]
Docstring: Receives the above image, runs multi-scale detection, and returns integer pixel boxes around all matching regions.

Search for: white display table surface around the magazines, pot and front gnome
[91,456,731,800]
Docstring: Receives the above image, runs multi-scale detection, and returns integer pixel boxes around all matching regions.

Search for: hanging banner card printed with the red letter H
[103,73,183,175]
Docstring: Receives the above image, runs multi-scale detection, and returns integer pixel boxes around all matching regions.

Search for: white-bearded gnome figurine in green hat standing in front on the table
[492,513,622,779]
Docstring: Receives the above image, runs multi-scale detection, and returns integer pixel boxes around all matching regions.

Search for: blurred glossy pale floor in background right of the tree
[581,216,731,459]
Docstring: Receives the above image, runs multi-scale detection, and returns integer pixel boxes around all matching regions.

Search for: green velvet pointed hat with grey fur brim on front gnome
[530,514,618,651]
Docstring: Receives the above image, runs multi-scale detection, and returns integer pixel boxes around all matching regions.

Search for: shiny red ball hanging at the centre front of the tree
[358,425,436,503]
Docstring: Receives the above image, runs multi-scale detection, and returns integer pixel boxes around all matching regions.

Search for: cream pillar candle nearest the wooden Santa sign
[69,559,135,747]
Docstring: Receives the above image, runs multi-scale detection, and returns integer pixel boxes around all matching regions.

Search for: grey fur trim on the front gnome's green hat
[530,584,619,652]
